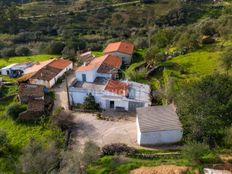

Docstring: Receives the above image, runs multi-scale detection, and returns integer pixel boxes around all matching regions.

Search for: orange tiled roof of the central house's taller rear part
[77,55,122,73]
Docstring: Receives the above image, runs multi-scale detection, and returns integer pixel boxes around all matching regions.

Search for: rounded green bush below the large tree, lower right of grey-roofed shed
[182,142,210,161]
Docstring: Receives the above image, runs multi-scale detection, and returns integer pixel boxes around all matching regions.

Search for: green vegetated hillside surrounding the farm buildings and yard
[0,0,232,174]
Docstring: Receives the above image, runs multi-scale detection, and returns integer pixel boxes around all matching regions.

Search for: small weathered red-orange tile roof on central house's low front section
[105,80,129,96]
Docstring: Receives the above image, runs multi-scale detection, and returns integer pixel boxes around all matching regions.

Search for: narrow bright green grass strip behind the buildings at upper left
[0,54,58,67]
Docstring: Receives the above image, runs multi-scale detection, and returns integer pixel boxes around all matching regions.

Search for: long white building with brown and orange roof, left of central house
[29,59,73,88]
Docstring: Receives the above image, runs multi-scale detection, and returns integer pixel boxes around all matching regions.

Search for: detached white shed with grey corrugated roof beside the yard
[136,105,183,145]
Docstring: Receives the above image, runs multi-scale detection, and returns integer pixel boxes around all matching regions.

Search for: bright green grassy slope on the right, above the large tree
[155,49,224,89]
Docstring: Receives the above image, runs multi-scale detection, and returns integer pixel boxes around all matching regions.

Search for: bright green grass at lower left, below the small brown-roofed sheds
[0,100,64,174]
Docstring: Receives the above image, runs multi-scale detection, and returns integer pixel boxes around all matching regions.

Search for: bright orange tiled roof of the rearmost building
[104,42,134,55]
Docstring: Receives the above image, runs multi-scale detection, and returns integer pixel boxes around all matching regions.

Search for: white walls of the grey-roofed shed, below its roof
[137,124,183,145]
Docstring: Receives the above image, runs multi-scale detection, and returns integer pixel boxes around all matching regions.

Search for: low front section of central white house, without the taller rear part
[69,77,151,111]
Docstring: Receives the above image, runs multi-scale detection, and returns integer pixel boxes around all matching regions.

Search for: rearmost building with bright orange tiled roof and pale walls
[103,42,134,64]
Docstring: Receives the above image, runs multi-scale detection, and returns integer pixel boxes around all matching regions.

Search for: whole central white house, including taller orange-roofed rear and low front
[69,55,151,111]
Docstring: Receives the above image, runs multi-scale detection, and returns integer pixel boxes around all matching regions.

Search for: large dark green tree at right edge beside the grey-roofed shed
[176,74,232,146]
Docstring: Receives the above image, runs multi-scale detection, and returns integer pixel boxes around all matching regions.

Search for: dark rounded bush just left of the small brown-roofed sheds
[6,103,27,120]
